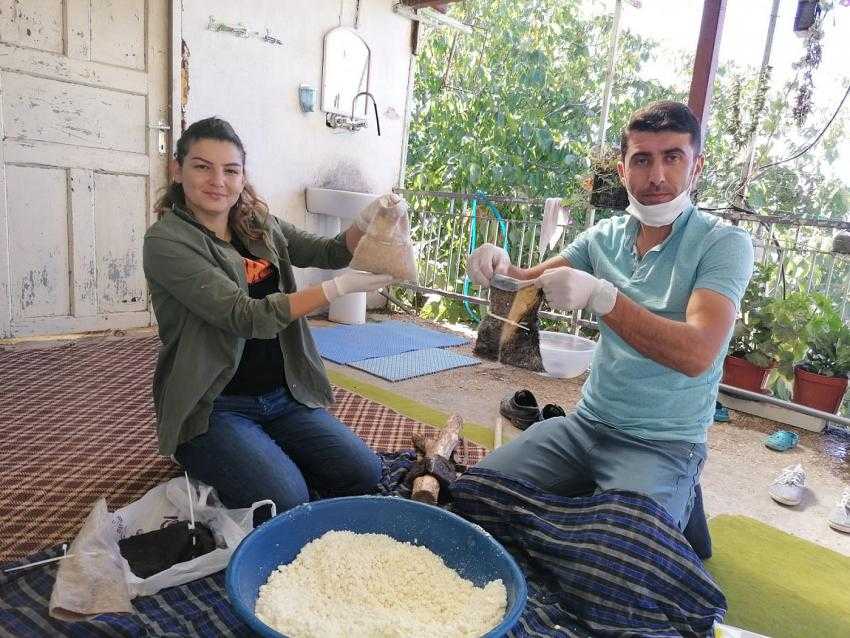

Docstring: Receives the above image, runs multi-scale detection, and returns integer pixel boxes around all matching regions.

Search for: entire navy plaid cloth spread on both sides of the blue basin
[0,452,726,638]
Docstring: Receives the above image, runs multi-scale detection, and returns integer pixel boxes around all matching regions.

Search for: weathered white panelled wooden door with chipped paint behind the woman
[0,0,171,338]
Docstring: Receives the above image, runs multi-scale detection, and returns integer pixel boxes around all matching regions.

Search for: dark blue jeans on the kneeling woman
[174,388,381,512]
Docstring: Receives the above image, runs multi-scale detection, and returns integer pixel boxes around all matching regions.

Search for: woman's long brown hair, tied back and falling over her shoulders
[153,117,269,239]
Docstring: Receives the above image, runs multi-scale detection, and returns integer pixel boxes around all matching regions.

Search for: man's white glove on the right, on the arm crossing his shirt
[537,266,617,317]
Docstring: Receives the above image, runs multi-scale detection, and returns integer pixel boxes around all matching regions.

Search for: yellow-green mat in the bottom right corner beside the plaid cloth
[705,515,850,638]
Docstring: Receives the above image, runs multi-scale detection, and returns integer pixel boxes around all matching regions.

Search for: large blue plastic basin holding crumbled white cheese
[226,496,528,638]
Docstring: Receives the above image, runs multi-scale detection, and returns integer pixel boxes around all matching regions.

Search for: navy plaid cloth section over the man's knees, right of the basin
[451,468,726,638]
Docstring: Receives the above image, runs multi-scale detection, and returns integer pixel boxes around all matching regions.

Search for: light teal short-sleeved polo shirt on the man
[561,206,753,443]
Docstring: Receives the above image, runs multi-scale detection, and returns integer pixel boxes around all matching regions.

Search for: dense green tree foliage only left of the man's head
[407,0,668,205]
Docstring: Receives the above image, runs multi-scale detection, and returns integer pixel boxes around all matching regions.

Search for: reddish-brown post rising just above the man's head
[688,0,726,141]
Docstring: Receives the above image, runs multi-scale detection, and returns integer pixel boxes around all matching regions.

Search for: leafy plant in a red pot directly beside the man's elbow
[722,264,778,392]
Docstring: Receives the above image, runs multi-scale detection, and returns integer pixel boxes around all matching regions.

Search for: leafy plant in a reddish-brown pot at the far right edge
[793,295,850,414]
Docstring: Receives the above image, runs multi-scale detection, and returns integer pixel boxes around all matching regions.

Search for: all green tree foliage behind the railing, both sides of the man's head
[406,0,850,318]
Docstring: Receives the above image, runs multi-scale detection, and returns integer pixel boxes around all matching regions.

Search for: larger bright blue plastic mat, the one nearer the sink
[311,321,467,364]
